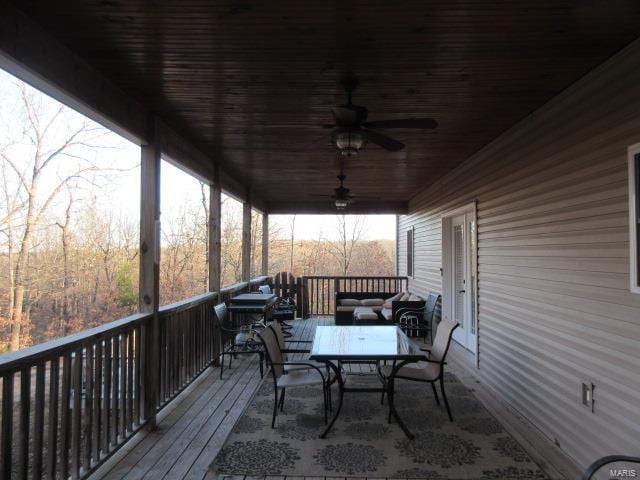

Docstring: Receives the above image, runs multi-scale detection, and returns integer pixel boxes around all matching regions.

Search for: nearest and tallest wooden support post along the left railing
[139,119,160,429]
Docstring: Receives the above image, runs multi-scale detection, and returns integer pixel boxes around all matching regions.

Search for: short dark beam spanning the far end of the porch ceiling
[267,200,408,215]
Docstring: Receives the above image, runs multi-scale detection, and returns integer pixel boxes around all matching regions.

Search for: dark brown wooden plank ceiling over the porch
[14,0,640,212]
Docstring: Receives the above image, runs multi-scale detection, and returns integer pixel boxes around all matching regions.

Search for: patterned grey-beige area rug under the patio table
[210,374,547,480]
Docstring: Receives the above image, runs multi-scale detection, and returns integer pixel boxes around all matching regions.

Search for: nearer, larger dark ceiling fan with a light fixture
[323,77,438,157]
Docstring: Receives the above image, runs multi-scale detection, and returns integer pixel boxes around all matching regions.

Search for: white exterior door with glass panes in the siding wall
[442,206,477,353]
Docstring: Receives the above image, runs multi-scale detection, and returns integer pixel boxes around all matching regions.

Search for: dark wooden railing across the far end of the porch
[298,276,408,318]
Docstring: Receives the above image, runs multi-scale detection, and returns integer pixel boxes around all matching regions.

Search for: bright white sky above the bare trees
[0,70,395,240]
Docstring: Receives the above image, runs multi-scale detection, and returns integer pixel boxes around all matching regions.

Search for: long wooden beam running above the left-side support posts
[0,0,264,210]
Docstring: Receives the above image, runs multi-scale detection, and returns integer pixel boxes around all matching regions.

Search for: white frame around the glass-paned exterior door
[441,201,480,368]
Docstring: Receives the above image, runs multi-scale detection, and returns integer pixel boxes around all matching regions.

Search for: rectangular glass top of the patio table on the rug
[309,325,426,362]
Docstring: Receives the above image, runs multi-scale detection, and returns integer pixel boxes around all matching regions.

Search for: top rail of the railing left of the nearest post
[0,313,151,375]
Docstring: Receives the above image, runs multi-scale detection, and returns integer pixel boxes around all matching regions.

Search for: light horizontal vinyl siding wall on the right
[398,42,640,467]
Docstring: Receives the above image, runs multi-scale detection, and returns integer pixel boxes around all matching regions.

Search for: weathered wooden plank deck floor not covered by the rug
[92,319,562,480]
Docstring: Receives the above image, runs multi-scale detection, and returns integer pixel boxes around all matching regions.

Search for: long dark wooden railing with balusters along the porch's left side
[0,277,269,480]
